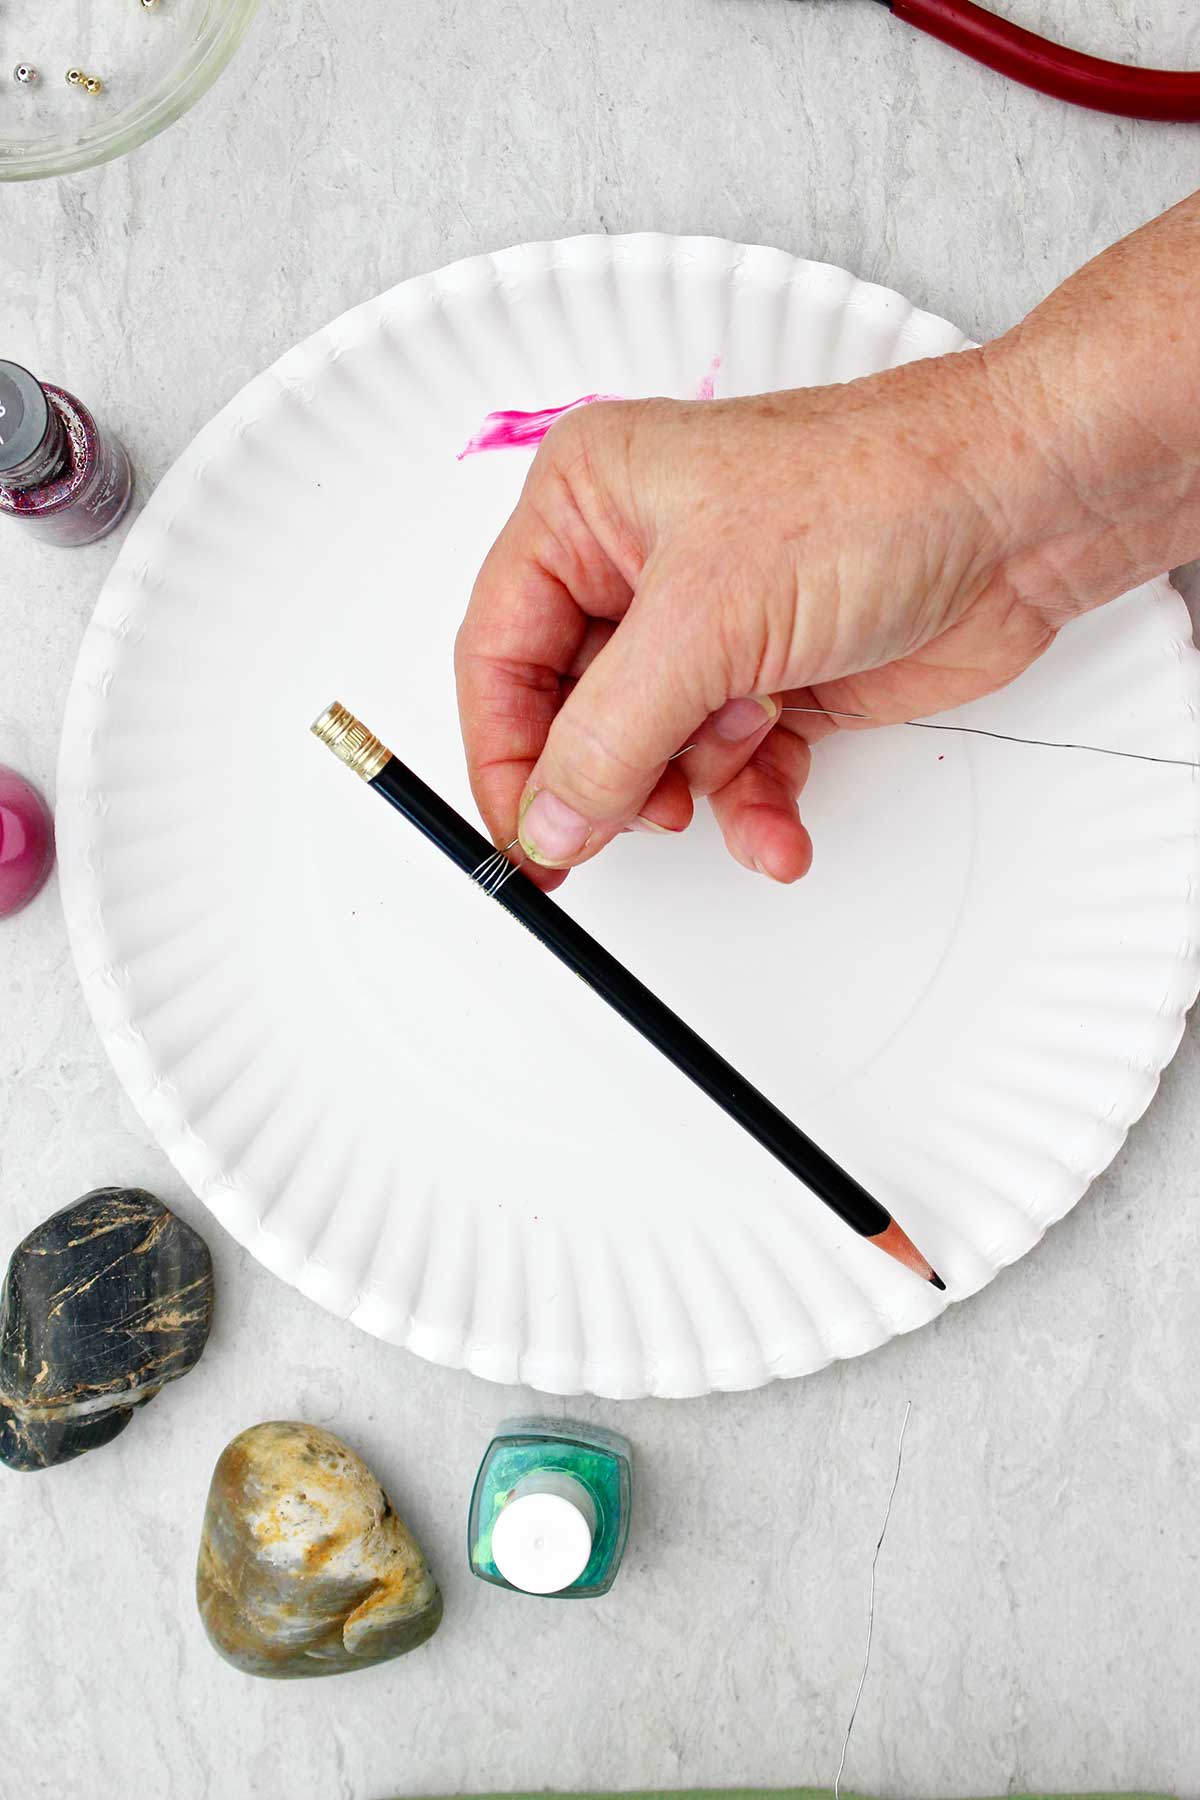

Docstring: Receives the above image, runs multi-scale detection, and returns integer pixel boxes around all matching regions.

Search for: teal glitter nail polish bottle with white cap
[468,1418,633,1600]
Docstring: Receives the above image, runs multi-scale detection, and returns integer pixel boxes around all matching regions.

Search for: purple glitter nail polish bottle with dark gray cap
[0,362,133,544]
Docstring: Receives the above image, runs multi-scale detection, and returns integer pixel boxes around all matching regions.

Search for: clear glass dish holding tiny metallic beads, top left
[0,0,259,182]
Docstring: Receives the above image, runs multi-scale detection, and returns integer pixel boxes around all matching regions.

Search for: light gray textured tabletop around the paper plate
[0,0,1200,1800]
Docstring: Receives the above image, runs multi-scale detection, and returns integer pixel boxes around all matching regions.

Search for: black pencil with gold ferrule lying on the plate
[313,700,946,1289]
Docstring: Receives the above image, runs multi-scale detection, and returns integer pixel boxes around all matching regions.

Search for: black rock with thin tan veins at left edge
[0,1188,212,1471]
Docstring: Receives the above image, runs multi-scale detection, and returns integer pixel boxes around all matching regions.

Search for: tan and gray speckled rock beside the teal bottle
[196,1422,441,1679]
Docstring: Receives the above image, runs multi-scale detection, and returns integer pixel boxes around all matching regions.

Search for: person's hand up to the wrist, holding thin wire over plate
[455,286,1187,887]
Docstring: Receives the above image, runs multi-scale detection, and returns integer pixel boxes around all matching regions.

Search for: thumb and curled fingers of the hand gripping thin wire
[455,403,827,887]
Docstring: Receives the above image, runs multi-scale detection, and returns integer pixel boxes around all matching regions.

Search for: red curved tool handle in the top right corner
[883,0,1200,121]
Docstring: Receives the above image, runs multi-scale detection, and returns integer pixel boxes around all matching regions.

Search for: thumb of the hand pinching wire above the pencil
[518,563,712,868]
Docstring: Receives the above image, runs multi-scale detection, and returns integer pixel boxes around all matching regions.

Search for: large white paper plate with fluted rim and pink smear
[58,236,1200,1395]
